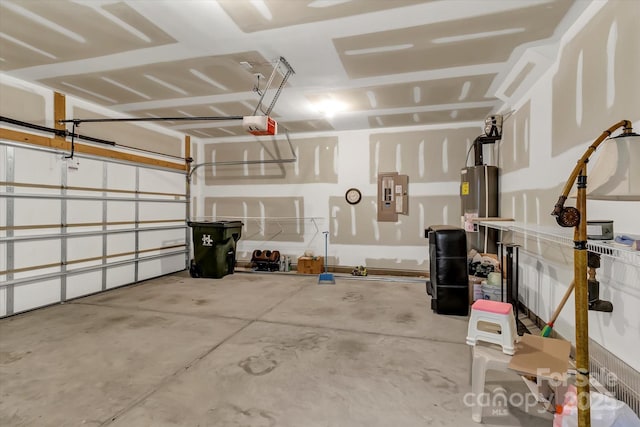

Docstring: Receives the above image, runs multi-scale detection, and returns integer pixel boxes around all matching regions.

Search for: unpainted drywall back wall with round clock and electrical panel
[194,123,482,273]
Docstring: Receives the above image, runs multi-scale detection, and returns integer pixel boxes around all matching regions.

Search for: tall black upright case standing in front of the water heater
[425,225,469,316]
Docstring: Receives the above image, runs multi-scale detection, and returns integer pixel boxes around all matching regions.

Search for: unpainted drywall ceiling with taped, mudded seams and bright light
[0,0,585,138]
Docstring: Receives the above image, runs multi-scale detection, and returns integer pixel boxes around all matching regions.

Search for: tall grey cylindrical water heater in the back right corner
[460,165,498,254]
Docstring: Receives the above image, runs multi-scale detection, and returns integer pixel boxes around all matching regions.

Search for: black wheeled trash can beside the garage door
[188,221,243,279]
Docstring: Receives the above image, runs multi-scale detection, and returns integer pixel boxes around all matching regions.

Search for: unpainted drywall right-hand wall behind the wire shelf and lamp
[499,1,640,370]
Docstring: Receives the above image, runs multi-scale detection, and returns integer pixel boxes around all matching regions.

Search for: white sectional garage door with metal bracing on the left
[0,141,189,317]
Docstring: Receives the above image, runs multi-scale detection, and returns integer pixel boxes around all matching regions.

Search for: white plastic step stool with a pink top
[467,299,518,355]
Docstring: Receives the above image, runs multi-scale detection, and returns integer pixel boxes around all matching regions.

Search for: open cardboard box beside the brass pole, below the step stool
[509,334,571,412]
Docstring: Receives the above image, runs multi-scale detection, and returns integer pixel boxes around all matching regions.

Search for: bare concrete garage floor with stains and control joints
[0,272,552,427]
